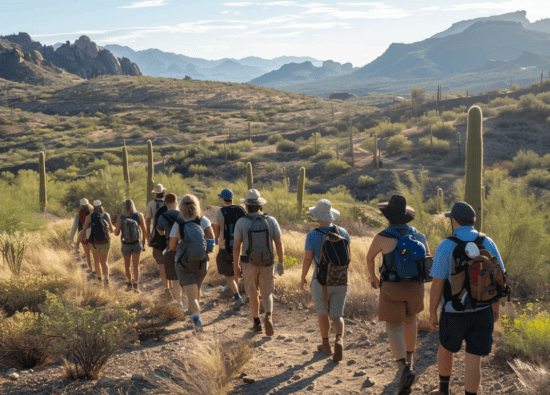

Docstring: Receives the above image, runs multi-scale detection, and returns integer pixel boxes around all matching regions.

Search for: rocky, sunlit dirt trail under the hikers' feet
[0,255,521,395]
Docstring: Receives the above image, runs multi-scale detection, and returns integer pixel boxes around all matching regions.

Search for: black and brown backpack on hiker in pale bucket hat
[315,226,351,287]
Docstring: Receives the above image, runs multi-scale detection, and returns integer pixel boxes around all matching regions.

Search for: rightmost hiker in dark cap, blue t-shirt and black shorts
[429,202,509,395]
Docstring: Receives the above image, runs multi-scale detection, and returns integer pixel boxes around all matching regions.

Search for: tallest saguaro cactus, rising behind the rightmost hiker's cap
[464,106,483,231]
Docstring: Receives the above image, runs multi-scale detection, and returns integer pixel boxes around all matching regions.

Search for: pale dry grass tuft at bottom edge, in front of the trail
[149,340,254,395]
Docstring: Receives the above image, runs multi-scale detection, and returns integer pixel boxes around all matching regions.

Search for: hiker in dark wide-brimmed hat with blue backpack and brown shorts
[367,195,429,394]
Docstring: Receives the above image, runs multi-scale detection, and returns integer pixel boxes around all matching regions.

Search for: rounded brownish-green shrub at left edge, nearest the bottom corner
[0,312,50,369]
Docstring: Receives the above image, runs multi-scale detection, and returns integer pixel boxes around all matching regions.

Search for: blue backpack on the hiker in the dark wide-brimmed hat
[380,226,431,283]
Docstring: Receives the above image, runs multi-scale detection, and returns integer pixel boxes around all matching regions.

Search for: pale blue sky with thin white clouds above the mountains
[0,0,550,66]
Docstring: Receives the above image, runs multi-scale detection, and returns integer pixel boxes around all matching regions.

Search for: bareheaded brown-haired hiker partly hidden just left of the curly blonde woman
[154,193,185,311]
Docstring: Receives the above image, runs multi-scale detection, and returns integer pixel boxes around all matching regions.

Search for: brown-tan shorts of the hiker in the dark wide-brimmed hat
[378,281,424,323]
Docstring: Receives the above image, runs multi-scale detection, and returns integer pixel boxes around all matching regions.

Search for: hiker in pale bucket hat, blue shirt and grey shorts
[302,199,350,362]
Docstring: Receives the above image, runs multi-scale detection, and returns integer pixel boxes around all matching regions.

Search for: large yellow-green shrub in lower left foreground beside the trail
[44,295,135,380]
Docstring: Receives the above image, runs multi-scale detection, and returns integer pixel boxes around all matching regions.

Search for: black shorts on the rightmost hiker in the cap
[439,307,495,357]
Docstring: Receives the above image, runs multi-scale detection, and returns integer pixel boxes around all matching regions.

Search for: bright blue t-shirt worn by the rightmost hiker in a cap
[430,226,505,313]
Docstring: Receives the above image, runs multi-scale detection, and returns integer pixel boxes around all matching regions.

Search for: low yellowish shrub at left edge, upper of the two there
[0,275,67,316]
